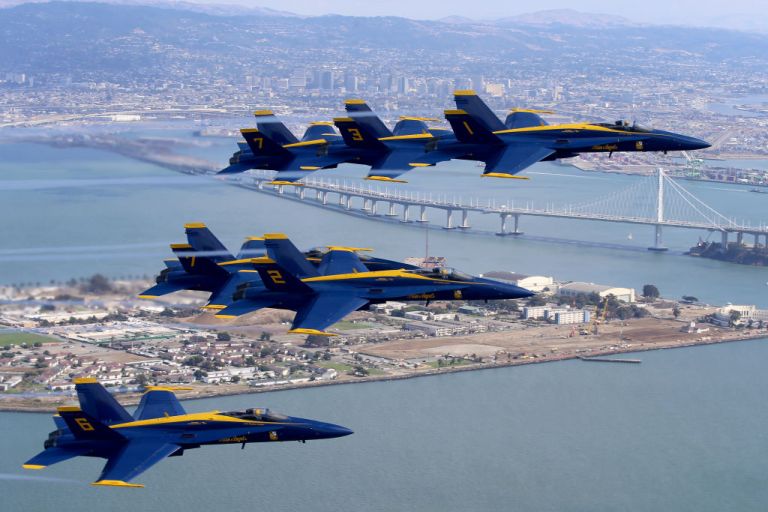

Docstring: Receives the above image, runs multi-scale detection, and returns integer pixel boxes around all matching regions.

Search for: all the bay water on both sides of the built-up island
[0,131,768,512]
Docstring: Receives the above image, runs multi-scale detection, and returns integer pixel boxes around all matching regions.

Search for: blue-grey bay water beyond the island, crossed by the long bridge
[0,139,768,307]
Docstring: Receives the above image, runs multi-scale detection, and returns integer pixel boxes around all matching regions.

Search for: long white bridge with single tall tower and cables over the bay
[231,168,768,251]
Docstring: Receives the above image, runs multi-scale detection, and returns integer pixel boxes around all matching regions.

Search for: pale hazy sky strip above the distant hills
[212,0,768,31]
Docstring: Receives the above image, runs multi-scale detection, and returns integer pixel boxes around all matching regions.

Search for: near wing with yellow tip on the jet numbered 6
[92,440,179,487]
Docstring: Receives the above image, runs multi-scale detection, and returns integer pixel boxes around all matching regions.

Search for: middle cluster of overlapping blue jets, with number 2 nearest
[139,223,533,336]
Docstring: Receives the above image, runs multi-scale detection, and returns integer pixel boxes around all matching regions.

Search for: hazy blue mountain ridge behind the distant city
[0,0,768,80]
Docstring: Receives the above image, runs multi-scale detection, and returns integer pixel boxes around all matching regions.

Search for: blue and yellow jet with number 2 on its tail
[216,234,533,336]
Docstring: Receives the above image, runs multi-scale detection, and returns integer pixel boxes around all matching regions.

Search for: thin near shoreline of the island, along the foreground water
[0,332,768,414]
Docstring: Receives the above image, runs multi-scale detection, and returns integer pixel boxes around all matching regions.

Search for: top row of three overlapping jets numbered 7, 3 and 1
[219,91,710,185]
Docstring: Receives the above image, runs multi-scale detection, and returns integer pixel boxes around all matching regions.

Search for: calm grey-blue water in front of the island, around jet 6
[0,340,768,512]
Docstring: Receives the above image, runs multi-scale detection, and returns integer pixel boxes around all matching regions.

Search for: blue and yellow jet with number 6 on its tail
[23,378,352,487]
